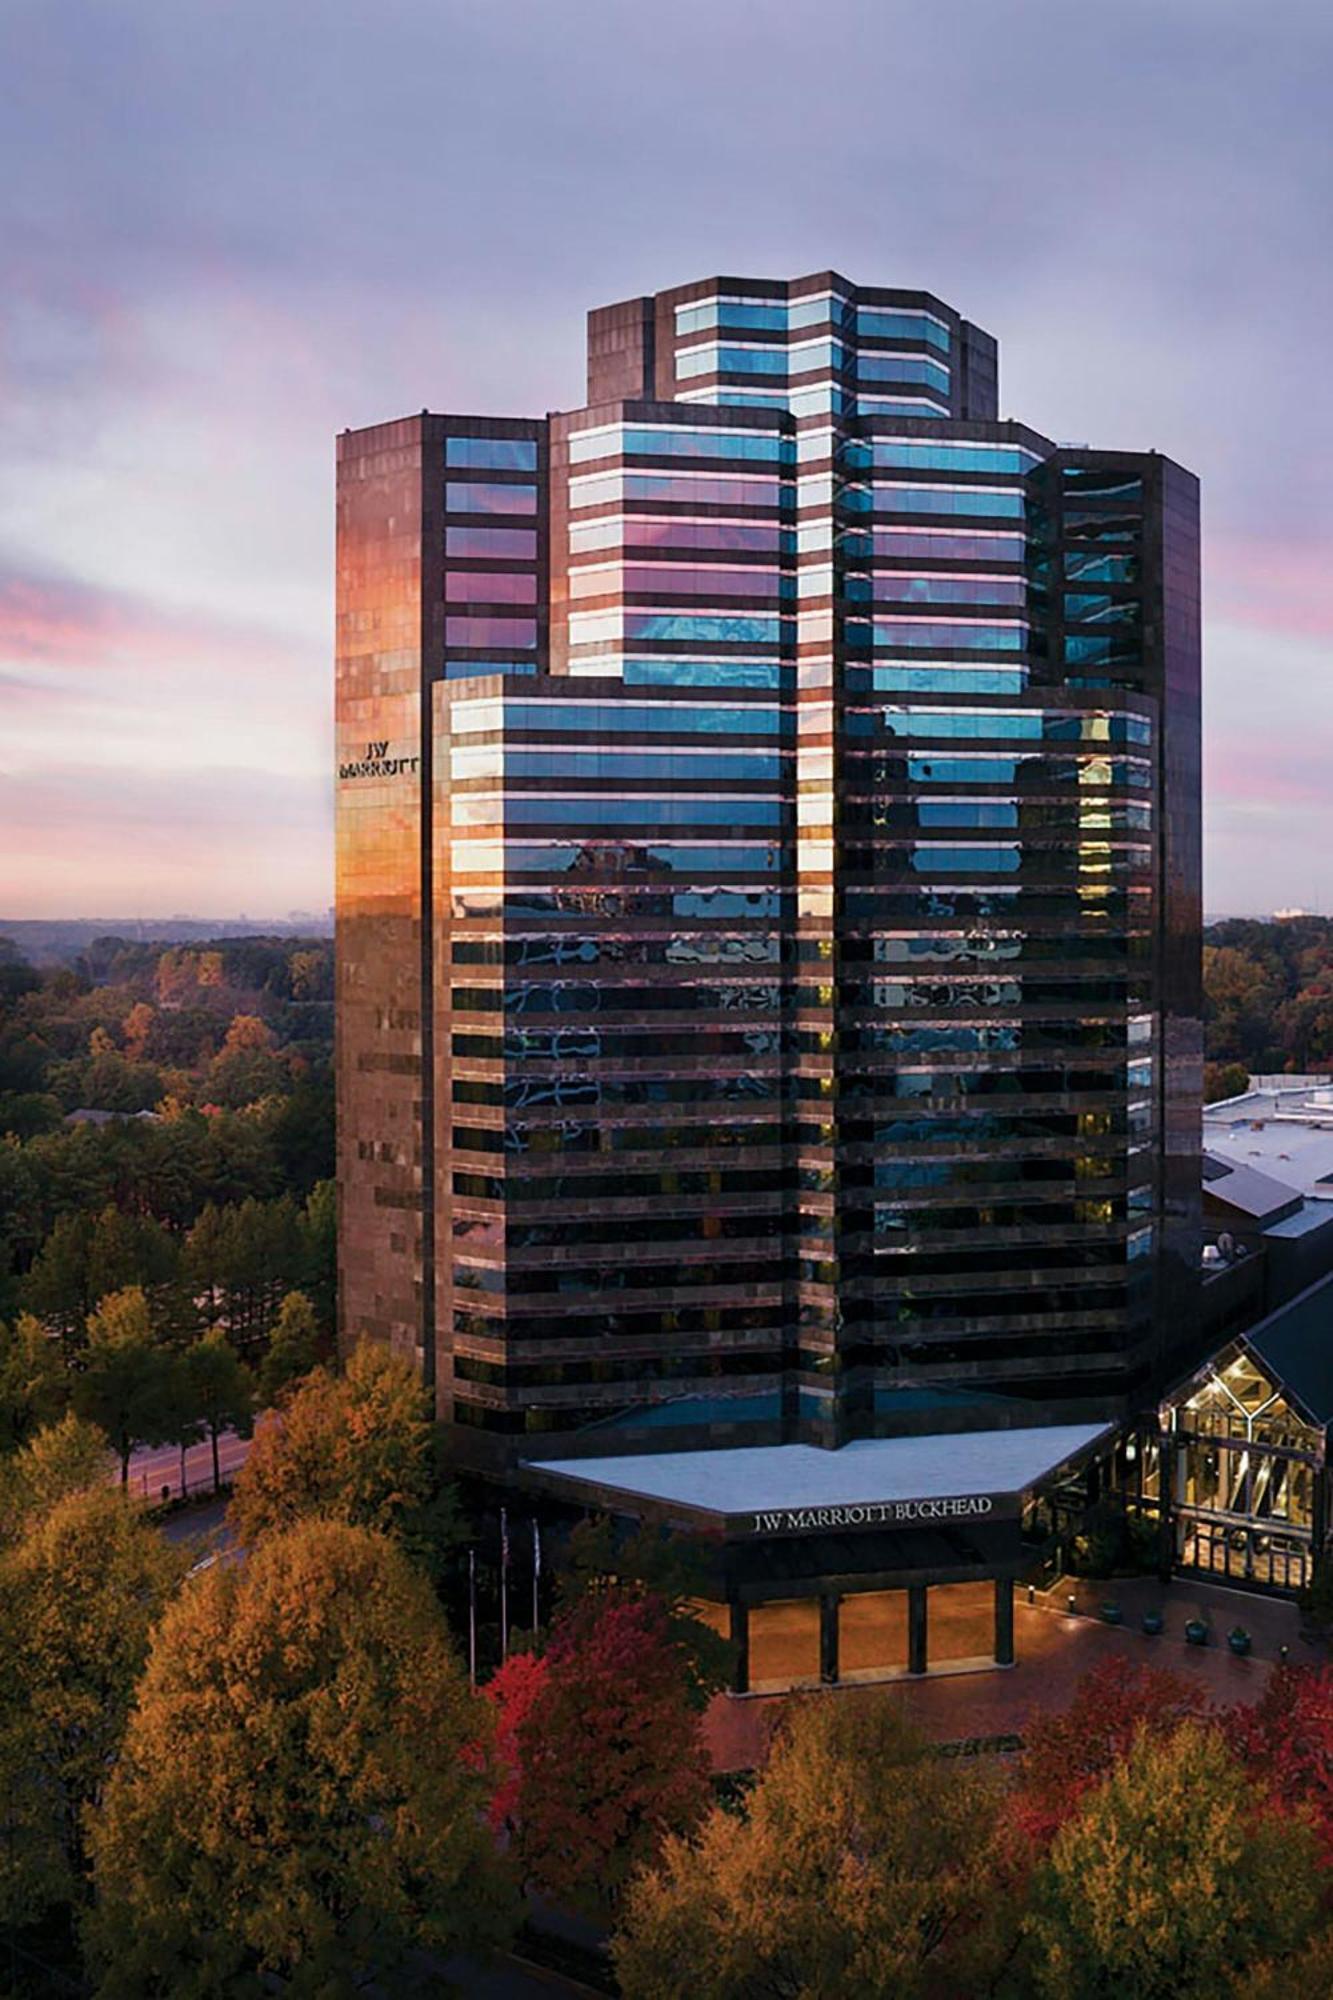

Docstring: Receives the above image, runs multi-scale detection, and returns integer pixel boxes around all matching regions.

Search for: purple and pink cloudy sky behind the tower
[0,0,1333,916]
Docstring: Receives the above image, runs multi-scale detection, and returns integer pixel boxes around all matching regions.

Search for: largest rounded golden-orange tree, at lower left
[88,1520,510,2000]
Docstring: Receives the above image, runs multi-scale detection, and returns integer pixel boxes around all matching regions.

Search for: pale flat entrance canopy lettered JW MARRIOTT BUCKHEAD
[524,1424,1115,1536]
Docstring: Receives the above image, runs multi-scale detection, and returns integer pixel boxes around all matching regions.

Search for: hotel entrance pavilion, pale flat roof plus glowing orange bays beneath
[522,1424,1111,1692]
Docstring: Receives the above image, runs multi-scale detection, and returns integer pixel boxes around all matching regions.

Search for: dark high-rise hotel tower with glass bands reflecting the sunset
[336,272,1201,1576]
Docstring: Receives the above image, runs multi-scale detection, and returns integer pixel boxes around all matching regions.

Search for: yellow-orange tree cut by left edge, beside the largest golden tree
[0,1486,188,1924]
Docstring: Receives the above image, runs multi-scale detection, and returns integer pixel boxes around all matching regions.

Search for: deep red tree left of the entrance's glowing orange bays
[510,1596,711,1916]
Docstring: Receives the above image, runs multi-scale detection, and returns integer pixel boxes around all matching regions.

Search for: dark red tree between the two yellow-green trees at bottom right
[1013,1656,1207,1846]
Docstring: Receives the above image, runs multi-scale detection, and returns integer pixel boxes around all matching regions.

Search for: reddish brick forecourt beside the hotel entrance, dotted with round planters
[705,1578,1327,1770]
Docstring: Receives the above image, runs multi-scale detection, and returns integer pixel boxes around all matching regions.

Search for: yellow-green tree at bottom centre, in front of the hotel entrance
[614,1690,1017,2000]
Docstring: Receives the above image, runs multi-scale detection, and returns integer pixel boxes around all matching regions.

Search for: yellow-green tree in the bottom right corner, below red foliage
[1027,1722,1323,2000]
